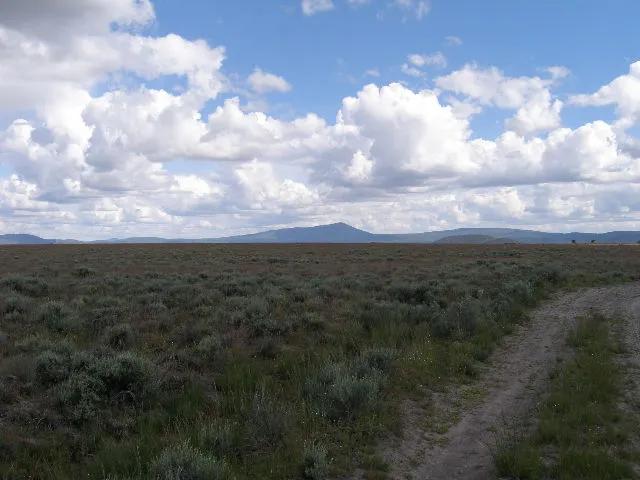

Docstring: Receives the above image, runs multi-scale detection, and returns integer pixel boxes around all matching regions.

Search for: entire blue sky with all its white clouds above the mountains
[0,0,640,239]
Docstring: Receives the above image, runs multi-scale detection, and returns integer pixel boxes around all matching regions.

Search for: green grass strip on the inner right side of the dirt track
[496,315,638,480]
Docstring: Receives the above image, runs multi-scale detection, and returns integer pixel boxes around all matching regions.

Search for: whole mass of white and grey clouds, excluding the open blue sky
[0,0,640,238]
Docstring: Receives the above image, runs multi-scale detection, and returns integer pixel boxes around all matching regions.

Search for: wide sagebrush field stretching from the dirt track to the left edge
[0,245,640,480]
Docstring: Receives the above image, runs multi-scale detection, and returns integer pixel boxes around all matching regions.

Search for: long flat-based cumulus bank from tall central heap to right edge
[308,84,640,196]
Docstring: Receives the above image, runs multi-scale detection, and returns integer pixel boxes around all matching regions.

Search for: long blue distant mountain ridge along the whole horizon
[0,222,640,245]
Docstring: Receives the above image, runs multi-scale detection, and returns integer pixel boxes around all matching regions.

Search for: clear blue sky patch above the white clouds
[153,0,640,131]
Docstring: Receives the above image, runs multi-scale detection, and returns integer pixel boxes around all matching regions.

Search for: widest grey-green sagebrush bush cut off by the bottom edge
[151,442,229,480]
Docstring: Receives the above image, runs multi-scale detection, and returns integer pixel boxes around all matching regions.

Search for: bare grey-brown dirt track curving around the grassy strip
[383,283,640,480]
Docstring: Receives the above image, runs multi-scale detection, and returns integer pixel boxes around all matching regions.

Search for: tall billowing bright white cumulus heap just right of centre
[320,83,473,188]
